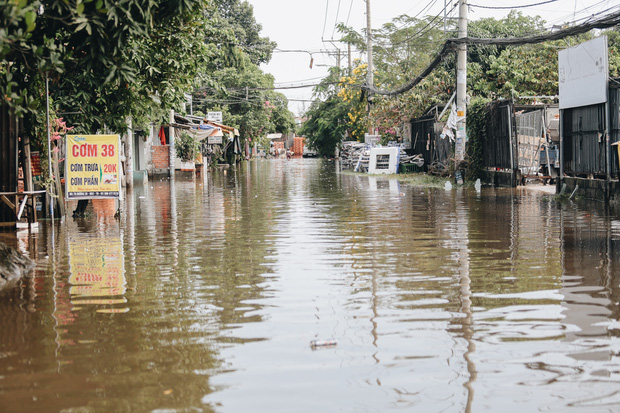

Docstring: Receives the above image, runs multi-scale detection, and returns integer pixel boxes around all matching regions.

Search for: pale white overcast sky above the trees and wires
[248,0,620,115]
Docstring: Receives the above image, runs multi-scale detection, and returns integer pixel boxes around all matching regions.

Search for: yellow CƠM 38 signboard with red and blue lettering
[65,135,122,199]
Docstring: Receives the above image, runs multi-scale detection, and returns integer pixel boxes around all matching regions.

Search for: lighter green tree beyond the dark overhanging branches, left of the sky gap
[193,0,295,150]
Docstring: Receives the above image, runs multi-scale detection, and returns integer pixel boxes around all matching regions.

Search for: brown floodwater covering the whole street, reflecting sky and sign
[0,159,620,413]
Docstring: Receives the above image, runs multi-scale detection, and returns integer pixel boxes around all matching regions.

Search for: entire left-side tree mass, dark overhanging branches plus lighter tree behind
[0,0,294,159]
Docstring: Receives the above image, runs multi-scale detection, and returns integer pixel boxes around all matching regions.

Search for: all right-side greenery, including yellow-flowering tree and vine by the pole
[301,10,620,180]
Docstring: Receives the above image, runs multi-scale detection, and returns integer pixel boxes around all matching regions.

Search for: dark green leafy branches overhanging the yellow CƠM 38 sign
[0,0,212,132]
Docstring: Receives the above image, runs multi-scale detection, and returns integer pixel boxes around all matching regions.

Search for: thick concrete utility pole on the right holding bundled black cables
[454,0,467,184]
